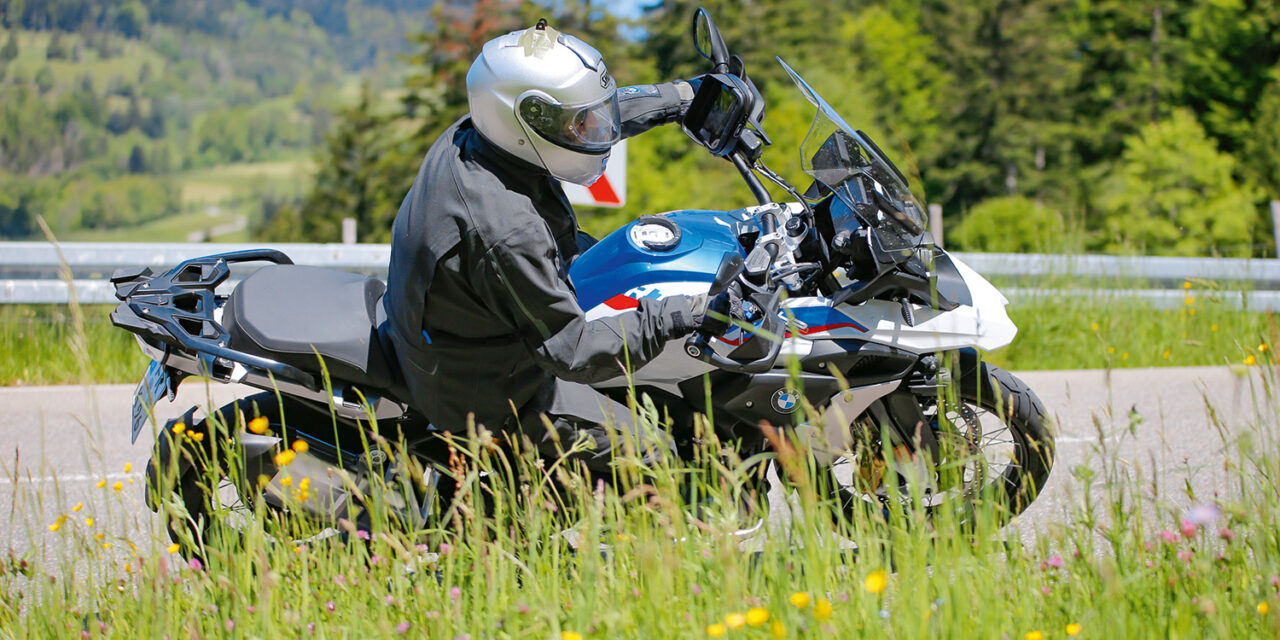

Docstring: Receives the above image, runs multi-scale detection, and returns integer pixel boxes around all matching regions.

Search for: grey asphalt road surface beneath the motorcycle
[0,367,1275,563]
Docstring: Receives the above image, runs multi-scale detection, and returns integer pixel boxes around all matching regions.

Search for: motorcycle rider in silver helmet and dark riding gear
[384,19,716,474]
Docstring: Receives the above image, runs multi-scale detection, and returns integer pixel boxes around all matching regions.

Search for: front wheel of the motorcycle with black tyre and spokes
[831,353,1053,526]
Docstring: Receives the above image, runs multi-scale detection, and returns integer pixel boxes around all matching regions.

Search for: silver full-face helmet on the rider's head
[467,19,622,184]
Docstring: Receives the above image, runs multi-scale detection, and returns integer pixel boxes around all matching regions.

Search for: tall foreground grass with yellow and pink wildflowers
[0,345,1280,640]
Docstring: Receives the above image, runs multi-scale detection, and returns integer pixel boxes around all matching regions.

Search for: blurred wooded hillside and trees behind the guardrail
[0,0,1280,257]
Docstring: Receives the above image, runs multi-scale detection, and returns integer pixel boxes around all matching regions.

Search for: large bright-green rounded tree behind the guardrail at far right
[1097,109,1258,256]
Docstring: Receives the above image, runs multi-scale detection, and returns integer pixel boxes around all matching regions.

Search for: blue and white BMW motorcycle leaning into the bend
[111,9,1053,550]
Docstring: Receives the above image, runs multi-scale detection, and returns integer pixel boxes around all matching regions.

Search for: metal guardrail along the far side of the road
[0,242,1280,311]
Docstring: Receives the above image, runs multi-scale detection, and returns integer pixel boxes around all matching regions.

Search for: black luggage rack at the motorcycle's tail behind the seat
[111,248,320,390]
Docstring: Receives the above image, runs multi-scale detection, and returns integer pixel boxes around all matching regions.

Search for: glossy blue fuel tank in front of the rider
[570,209,744,308]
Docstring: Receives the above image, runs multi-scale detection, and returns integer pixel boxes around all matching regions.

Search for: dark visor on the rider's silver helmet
[520,93,622,154]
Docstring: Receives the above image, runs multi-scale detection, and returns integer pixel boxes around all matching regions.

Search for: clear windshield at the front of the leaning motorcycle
[778,58,924,248]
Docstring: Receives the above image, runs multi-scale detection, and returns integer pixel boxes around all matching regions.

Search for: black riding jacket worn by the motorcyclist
[384,82,694,430]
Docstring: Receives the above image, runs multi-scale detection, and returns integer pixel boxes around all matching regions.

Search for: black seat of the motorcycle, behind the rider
[223,265,398,396]
